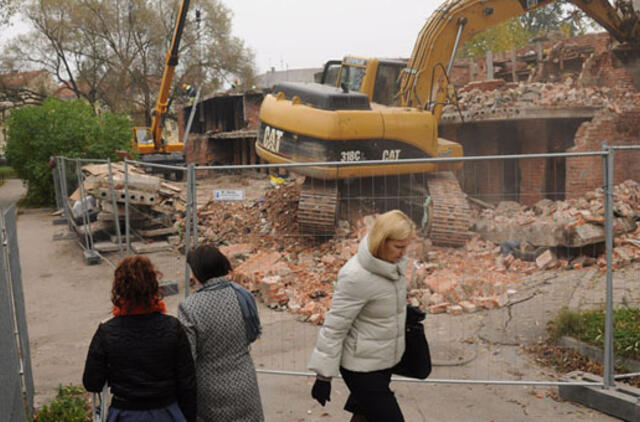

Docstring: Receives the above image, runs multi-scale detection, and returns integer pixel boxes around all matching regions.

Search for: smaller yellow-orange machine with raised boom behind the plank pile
[131,0,189,179]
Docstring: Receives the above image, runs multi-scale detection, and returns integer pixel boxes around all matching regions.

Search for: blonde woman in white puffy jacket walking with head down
[309,210,414,422]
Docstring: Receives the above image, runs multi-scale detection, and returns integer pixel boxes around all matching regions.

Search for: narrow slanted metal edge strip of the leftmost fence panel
[4,205,34,419]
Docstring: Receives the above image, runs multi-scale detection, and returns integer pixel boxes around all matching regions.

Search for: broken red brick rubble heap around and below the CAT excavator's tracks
[192,182,572,324]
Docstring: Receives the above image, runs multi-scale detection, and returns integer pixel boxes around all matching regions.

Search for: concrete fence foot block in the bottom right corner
[558,371,640,422]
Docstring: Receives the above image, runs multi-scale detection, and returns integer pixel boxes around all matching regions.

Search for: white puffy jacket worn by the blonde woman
[309,236,407,377]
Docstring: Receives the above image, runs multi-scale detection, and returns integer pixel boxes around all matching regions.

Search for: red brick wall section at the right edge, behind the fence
[566,109,640,198]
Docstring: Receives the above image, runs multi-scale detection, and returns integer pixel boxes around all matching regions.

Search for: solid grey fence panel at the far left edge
[0,208,26,422]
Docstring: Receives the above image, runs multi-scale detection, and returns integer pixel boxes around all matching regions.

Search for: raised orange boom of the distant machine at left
[150,0,189,152]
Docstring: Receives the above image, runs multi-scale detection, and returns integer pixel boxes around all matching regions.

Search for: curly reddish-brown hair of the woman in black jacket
[111,255,161,310]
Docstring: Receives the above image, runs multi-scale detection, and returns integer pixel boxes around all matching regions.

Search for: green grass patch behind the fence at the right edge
[547,306,640,360]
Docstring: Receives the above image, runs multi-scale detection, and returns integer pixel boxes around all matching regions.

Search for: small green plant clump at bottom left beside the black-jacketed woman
[34,385,92,422]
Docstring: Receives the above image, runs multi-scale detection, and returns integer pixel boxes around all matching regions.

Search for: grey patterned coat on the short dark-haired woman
[178,278,264,422]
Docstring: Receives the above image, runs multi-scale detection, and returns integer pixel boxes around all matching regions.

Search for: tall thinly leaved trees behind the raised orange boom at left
[0,0,254,124]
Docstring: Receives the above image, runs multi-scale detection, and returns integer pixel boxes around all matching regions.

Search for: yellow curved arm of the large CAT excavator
[400,0,640,121]
